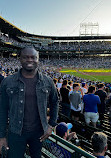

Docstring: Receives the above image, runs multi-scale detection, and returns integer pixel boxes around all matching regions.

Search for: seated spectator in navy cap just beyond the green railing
[56,122,77,141]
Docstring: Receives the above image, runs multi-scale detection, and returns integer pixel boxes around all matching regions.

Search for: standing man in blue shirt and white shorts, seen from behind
[83,86,101,127]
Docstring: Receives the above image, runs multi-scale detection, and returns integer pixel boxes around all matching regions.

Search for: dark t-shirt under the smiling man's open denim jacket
[22,76,43,132]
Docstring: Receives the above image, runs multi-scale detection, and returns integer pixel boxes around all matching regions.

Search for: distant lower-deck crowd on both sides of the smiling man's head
[0,57,111,75]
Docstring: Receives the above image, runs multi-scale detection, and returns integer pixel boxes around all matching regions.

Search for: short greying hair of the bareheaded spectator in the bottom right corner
[91,132,107,153]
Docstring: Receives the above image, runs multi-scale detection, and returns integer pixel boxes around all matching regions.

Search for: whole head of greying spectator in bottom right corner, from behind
[91,132,108,158]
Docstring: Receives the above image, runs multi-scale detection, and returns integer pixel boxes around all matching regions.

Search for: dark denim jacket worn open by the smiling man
[0,70,58,138]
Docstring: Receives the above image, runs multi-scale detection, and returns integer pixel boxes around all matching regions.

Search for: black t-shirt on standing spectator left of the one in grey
[60,87,70,104]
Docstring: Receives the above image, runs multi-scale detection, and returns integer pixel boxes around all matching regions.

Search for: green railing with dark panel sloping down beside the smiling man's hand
[24,134,95,158]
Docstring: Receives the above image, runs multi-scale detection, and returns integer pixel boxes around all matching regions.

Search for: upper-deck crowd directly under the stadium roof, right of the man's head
[40,41,111,51]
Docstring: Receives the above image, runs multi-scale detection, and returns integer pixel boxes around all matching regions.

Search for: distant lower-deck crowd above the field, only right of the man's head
[40,57,111,69]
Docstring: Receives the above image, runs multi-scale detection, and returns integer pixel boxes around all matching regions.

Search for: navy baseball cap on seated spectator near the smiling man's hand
[56,122,68,137]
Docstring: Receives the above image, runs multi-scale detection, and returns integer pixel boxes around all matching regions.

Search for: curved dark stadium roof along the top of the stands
[0,16,111,40]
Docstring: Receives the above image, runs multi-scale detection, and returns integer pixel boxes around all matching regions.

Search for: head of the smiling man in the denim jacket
[20,48,39,71]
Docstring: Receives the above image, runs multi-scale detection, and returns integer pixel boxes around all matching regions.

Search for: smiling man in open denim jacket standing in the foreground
[0,47,58,158]
